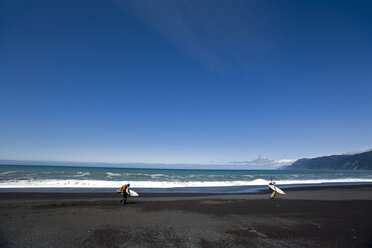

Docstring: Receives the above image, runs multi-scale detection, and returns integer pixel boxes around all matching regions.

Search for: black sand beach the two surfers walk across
[0,185,372,247]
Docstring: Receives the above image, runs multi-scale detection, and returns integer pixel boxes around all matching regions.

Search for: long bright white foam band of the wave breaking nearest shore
[0,178,372,188]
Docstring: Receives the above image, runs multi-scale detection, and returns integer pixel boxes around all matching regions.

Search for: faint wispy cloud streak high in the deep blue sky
[116,0,272,73]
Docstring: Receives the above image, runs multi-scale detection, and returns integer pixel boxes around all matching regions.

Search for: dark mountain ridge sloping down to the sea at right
[284,151,372,170]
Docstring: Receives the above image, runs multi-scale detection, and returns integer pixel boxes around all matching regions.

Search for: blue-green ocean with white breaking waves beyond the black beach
[0,165,372,193]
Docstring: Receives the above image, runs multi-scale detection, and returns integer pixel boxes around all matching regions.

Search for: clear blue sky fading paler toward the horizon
[0,0,372,167]
